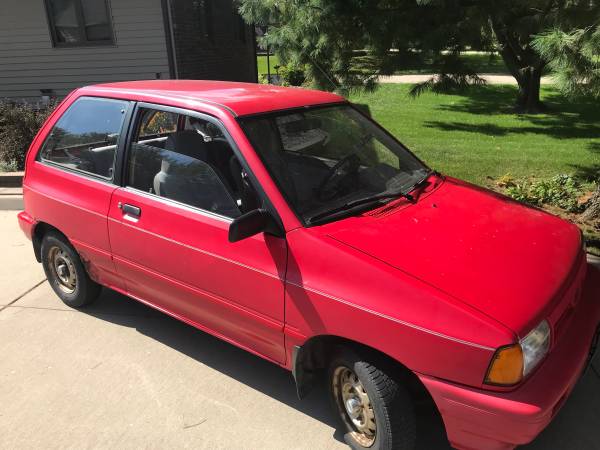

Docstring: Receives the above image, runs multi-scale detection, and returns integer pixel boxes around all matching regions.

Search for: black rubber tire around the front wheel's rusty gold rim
[328,349,416,450]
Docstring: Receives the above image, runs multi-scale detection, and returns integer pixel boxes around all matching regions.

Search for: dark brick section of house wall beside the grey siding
[170,0,257,82]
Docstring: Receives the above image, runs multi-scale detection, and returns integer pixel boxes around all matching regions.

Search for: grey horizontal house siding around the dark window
[0,0,170,101]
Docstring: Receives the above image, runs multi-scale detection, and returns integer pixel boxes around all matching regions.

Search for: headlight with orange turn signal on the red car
[485,320,550,386]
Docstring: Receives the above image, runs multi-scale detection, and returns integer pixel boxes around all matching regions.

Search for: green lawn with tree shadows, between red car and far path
[351,84,600,185]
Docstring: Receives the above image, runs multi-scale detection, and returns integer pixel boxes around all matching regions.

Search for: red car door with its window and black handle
[109,104,287,363]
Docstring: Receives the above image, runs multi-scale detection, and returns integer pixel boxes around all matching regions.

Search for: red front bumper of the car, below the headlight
[419,267,600,450]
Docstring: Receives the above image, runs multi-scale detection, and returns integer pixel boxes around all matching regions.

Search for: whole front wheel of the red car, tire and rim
[329,351,416,450]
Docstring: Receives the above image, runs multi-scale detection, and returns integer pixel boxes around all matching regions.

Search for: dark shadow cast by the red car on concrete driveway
[84,289,600,450]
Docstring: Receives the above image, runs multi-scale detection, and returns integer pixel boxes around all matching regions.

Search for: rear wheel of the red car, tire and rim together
[41,231,102,308]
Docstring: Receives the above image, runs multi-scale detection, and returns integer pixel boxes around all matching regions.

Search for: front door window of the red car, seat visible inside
[127,109,257,218]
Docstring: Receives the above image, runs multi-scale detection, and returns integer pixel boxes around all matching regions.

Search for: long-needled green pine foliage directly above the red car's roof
[240,0,418,90]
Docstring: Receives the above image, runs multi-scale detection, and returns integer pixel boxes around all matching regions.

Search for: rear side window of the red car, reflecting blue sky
[38,97,129,179]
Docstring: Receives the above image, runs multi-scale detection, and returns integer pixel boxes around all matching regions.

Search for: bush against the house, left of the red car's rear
[0,101,56,171]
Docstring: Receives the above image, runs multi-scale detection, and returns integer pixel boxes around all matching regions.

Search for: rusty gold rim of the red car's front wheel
[332,366,377,447]
